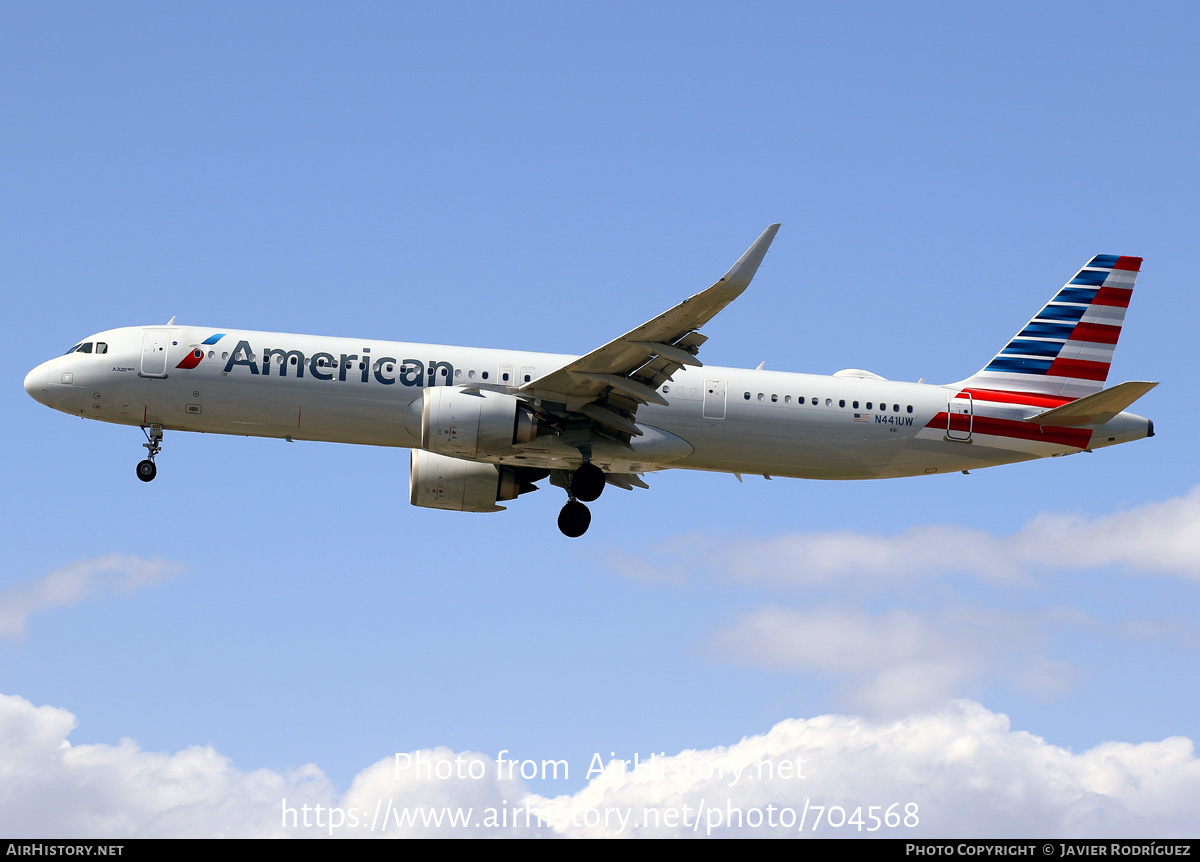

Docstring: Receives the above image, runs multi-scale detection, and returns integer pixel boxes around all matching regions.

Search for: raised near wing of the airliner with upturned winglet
[520,225,779,444]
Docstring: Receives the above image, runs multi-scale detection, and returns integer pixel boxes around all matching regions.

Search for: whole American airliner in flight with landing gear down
[25,225,1158,538]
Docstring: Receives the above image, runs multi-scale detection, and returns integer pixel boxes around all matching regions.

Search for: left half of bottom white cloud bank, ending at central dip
[0,695,546,838]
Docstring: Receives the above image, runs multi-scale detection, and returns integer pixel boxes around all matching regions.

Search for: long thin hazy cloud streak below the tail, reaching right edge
[612,487,1200,586]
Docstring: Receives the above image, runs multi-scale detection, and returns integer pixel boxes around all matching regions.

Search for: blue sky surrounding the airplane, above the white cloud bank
[0,2,1200,834]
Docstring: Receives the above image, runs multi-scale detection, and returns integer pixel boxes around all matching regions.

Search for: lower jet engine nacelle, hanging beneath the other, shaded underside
[408,449,548,511]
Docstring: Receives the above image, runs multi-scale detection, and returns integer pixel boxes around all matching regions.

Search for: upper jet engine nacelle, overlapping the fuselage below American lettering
[421,387,538,457]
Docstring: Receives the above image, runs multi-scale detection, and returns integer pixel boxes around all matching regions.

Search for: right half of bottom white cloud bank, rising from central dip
[530,701,1200,838]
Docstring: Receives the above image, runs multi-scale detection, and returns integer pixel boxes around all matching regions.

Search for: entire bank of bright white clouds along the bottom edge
[0,691,1200,839]
